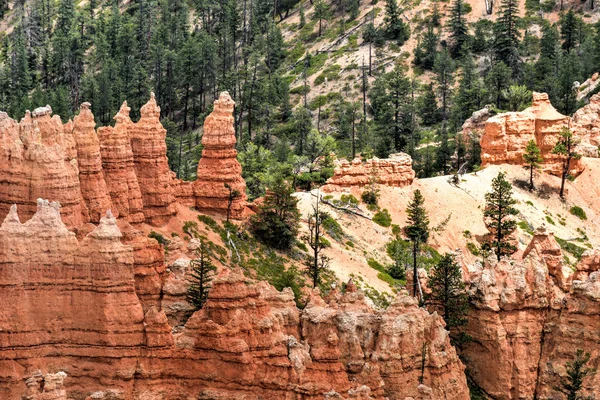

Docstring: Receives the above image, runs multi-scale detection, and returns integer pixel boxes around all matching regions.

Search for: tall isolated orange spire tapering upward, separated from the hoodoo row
[194,92,246,219]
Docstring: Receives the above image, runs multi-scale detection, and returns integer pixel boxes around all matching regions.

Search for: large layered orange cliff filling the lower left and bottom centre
[0,200,468,400]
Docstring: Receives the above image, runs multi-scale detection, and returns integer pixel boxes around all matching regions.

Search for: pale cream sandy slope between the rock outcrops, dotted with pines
[298,159,600,292]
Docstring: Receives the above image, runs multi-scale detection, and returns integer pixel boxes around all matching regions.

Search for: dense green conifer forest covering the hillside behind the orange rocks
[0,0,600,198]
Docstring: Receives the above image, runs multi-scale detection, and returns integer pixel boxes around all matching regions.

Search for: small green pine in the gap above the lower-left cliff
[187,240,217,310]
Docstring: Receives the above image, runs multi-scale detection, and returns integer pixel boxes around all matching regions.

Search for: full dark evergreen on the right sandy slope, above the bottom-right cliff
[483,172,519,261]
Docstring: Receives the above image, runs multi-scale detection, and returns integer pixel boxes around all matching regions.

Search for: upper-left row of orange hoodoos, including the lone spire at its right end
[0,93,246,227]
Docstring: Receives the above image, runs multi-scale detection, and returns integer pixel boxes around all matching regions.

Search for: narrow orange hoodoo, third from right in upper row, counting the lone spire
[98,102,144,223]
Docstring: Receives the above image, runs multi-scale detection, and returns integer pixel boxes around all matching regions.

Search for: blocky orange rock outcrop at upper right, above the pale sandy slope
[481,93,584,175]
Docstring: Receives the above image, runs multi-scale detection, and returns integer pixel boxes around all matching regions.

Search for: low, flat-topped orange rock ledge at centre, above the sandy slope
[322,153,415,192]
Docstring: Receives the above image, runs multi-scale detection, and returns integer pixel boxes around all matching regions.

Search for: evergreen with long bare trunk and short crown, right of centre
[404,189,429,300]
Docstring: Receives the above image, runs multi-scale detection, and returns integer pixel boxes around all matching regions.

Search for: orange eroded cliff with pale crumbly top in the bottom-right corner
[464,228,600,400]
